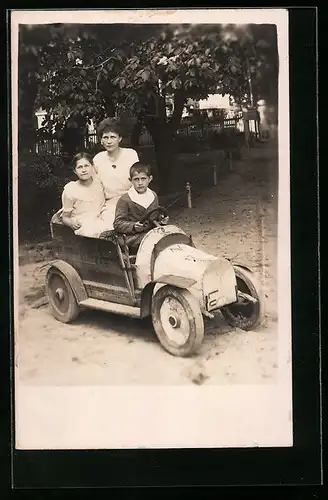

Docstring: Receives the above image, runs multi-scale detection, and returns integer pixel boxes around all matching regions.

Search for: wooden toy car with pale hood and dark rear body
[46,207,263,356]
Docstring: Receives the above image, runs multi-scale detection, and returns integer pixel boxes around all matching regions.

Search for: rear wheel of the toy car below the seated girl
[46,267,80,323]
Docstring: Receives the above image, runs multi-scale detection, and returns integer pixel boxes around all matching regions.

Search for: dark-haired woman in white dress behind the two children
[93,118,139,228]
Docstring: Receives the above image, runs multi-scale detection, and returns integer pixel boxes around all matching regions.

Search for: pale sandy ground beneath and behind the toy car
[15,145,278,385]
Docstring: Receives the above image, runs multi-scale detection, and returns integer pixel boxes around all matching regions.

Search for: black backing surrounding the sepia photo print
[0,7,323,498]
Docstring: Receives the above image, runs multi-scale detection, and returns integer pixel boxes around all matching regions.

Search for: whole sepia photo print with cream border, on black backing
[11,9,293,449]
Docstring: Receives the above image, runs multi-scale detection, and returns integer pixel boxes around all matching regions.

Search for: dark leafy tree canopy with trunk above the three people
[21,24,278,189]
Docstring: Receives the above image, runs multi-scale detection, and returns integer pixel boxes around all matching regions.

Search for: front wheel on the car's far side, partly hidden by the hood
[221,266,264,330]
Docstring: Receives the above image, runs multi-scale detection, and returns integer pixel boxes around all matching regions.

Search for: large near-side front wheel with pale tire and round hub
[151,285,204,357]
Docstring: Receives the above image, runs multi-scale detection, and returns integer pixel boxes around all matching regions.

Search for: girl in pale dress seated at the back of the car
[62,152,109,238]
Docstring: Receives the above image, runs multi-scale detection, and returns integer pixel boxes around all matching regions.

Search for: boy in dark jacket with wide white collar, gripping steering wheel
[114,162,168,249]
